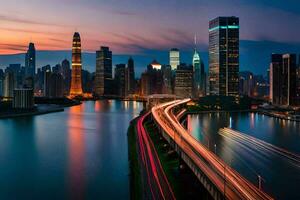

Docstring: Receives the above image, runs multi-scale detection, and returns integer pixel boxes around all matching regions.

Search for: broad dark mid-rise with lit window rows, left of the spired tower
[174,64,193,98]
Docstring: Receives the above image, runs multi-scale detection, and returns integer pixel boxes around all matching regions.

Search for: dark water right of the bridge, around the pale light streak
[188,113,300,199]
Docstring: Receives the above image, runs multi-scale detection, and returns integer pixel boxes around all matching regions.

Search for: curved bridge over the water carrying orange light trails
[151,99,272,200]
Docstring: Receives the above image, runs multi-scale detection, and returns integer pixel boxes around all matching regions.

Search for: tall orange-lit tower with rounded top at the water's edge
[70,32,83,96]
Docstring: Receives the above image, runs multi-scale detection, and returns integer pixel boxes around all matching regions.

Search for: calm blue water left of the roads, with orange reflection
[0,101,142,199]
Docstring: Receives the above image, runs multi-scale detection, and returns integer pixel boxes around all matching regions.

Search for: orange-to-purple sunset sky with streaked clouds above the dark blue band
[0,0,300,54]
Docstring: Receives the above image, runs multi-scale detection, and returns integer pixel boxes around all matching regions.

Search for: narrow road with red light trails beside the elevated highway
[136,113,175,200]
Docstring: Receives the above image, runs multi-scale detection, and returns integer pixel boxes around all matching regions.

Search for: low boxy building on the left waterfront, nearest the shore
[13,88,34,109]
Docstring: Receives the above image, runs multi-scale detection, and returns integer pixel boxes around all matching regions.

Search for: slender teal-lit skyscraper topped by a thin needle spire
[193,37,206,97]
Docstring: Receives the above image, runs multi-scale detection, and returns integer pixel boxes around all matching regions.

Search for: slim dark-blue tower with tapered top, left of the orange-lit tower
[25,43,36,78]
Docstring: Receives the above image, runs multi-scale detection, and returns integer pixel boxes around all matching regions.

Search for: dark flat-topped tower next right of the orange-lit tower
[95,47,112,96]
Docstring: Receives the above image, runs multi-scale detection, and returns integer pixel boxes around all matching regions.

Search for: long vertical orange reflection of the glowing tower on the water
[68,104,85,199]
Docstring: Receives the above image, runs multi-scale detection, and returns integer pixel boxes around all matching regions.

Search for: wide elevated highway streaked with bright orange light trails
[151,99,273,200]
